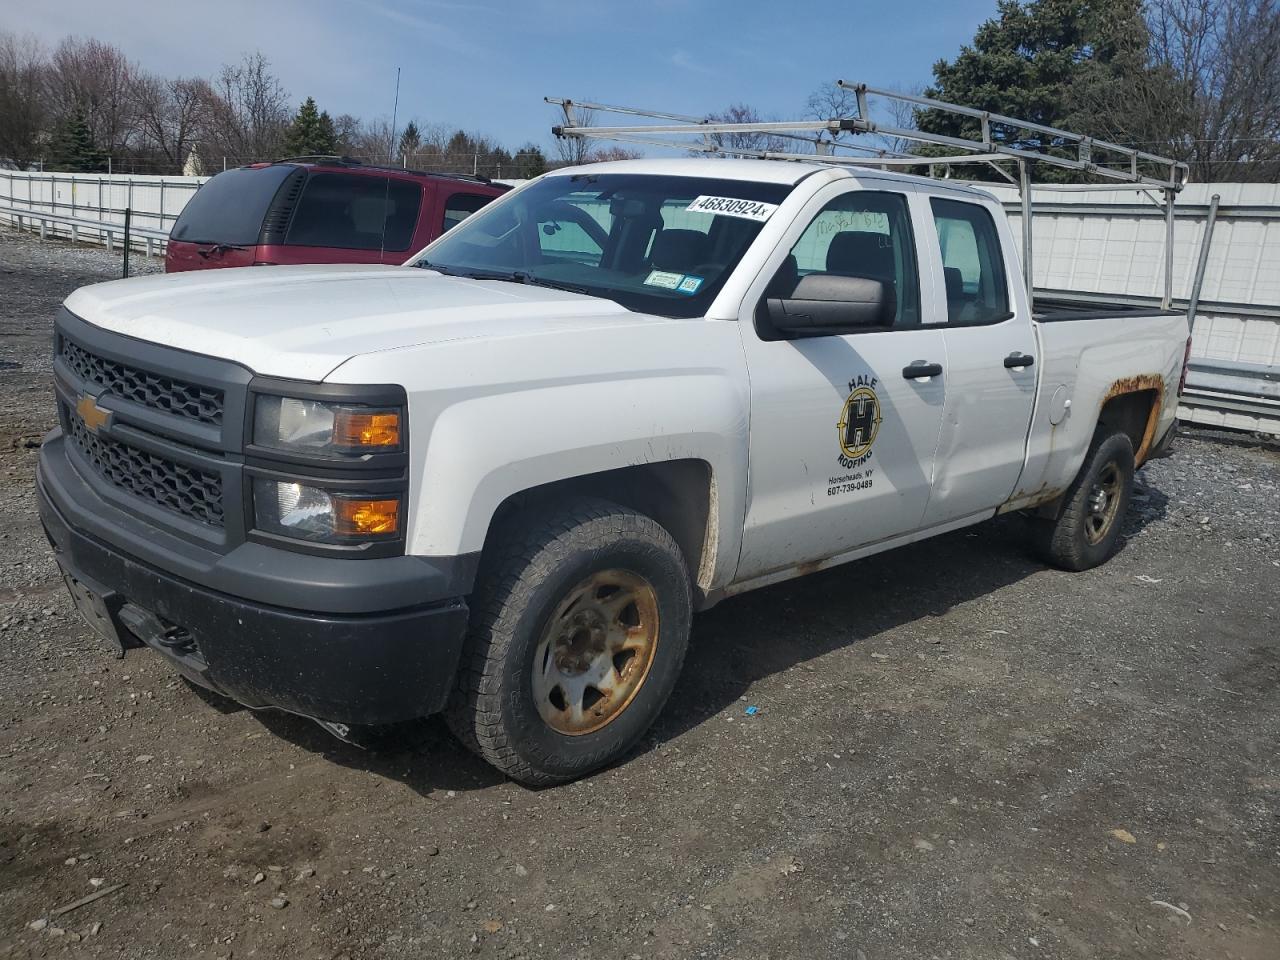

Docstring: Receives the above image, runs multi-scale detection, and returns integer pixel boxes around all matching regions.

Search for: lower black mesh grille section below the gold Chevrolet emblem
[63,407,223,527]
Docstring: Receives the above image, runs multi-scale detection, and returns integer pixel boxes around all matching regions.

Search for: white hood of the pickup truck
[67,264,672,380]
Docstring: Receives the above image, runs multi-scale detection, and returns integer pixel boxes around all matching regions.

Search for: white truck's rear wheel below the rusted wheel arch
[1036,430,1134,571]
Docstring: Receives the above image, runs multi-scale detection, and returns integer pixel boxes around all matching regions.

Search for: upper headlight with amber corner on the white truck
[253,394,403,453]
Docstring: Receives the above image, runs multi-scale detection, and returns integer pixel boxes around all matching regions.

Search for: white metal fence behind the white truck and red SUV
[0,170,1280,434]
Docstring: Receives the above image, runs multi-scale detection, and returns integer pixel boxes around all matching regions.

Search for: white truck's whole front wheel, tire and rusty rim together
[445,500,692,786]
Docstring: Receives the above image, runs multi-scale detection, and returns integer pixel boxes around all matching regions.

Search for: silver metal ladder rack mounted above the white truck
[545,79,1190,308]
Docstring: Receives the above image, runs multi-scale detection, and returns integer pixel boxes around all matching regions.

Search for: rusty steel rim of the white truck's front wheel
[532,570,658,736]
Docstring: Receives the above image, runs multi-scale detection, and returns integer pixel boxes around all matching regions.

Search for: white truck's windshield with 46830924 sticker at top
[416,174,791,316]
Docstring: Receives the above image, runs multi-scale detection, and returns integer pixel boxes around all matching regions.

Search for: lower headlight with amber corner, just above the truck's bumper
[253,479,401,544]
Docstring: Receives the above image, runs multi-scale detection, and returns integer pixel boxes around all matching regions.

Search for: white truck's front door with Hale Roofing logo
[736,178,946,581]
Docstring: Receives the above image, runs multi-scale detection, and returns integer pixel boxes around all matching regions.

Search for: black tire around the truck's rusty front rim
[445,499,692,786]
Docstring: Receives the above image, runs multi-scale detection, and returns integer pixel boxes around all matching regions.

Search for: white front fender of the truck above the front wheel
[328,321,750,586]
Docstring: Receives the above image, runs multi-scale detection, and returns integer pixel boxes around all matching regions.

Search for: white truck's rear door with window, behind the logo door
[922,196,1037,526]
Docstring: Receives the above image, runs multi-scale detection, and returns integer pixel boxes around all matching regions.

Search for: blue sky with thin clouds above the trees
[10,0,996,147]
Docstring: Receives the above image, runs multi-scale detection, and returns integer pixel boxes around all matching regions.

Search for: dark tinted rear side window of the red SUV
[284,173,422,251]
